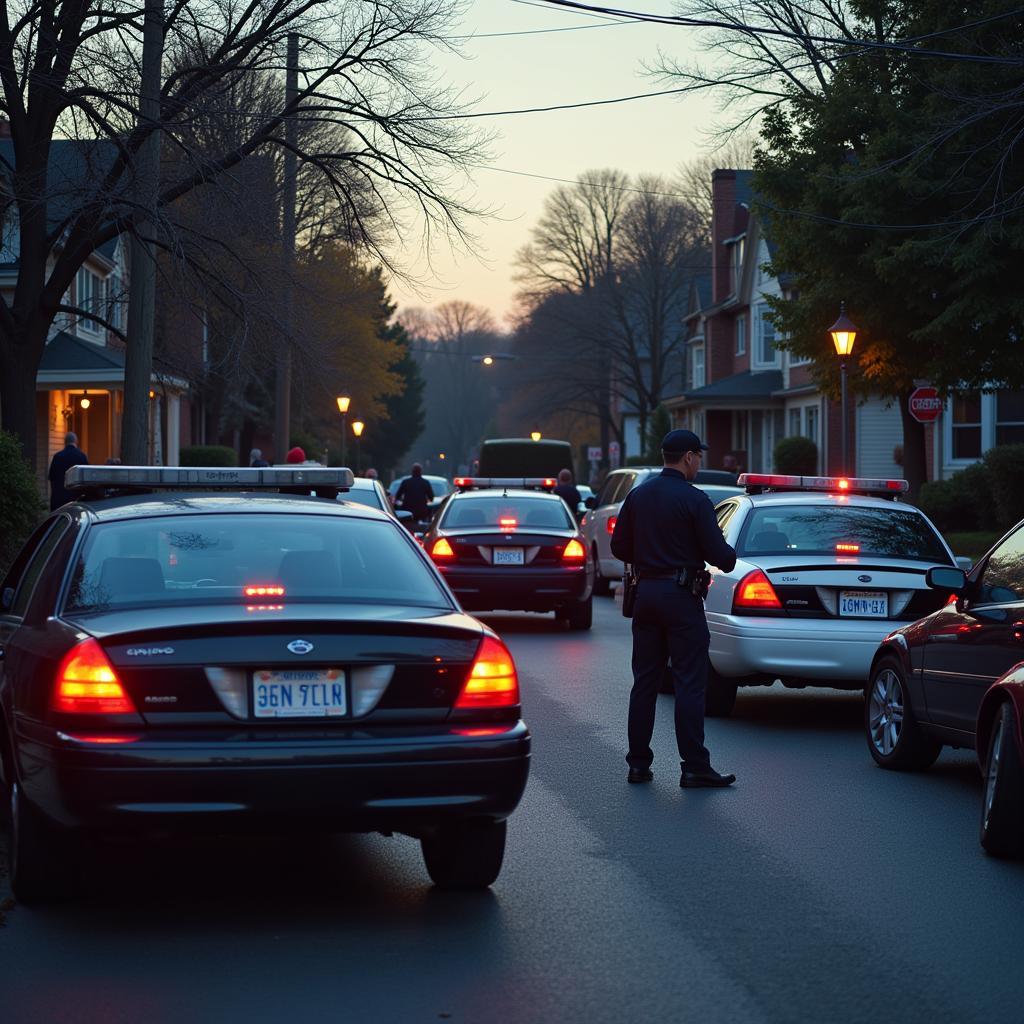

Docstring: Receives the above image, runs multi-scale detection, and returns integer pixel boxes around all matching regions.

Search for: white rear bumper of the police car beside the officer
[708,614,906,688]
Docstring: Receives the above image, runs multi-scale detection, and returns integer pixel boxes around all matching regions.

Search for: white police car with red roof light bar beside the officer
[705,473,956,715]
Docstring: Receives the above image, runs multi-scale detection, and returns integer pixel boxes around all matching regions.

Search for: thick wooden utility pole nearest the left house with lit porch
[121,0,164,466]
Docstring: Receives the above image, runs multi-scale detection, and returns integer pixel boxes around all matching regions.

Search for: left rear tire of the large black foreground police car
[7,781,74,904]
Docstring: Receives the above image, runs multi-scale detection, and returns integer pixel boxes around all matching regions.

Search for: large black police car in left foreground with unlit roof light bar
[0,466,529,901]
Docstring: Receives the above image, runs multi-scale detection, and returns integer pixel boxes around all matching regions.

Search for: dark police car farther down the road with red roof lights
[423,476,594,630]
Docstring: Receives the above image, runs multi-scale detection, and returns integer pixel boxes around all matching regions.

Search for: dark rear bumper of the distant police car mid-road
[440,565,594,611]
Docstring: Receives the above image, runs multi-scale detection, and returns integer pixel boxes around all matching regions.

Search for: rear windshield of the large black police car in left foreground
[66,514,451,612]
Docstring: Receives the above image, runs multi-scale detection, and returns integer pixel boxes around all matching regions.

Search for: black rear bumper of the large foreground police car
[17,722,530,835]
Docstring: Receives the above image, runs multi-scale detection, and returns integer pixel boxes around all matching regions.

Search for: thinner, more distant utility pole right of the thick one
[273,32,299,462]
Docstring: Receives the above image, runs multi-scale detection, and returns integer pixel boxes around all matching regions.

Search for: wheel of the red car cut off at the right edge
[980,702,1024,857]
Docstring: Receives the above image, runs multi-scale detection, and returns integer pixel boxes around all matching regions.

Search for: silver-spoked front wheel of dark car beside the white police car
[864,657,942,771]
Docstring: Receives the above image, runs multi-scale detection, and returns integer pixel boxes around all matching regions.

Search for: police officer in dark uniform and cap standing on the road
[611,430,736,786]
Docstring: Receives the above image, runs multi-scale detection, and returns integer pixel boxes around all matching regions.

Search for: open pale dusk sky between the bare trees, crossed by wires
[392,0,717,326]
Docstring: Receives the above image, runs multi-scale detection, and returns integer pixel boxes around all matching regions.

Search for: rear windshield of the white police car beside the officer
[737,505,949,564]
